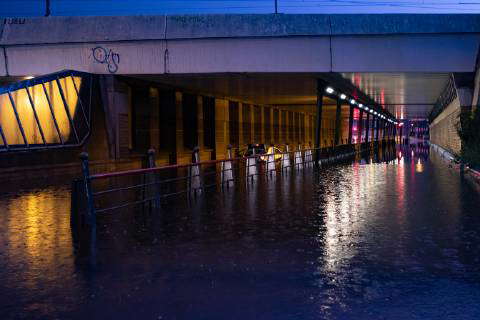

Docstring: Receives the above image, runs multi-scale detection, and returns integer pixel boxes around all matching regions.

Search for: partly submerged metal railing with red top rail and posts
[72,145,358,224]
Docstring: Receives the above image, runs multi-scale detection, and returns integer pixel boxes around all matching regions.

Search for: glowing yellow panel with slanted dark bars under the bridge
[0,71,92,150]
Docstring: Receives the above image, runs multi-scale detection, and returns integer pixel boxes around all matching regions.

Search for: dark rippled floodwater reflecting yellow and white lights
[0,147,480,320]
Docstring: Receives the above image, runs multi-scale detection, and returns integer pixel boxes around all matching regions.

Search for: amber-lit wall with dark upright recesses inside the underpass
[98,76,320,165]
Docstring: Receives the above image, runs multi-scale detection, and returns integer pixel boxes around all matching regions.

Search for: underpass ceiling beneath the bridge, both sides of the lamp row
[136,73,449,119]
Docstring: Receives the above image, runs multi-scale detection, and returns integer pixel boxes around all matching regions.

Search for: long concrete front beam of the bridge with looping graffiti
[0,15,480,76]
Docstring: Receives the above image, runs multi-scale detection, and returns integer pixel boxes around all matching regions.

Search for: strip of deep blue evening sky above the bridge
[0,0,480,17]
